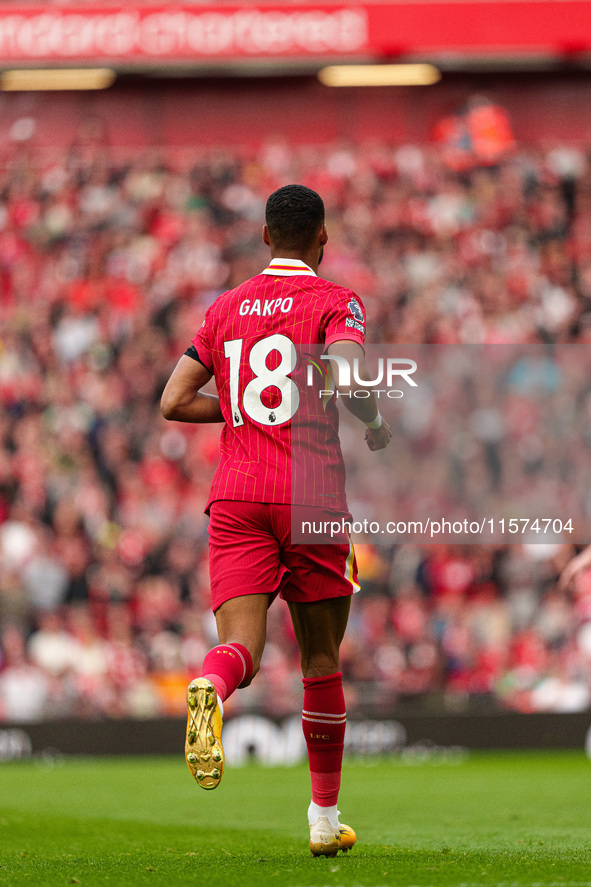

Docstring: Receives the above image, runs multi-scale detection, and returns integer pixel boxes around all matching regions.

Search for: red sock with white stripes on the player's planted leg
[302,671,347,807]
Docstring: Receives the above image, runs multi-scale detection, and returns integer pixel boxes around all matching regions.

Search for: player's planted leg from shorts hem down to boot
[288,596,356,856]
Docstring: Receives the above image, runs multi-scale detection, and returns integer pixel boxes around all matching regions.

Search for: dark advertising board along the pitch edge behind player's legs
[0,711,591,766]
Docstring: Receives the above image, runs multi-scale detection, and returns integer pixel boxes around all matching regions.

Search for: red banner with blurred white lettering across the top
[0,0,591,65]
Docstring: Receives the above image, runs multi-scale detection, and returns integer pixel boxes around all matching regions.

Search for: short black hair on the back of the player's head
[265,185,324,250]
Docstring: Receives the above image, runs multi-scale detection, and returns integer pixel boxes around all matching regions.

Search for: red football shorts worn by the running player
[209,499,359,613]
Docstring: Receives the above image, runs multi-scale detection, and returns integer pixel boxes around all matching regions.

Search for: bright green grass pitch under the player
[0,753,591,887]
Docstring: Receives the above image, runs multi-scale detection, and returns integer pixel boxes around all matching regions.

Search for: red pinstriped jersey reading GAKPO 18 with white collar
[192,258,365,511]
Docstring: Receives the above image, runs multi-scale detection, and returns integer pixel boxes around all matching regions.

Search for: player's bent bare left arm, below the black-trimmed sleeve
[160,354,224,422]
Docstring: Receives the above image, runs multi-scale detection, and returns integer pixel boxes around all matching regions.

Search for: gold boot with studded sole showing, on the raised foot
[185,678,224,789]
